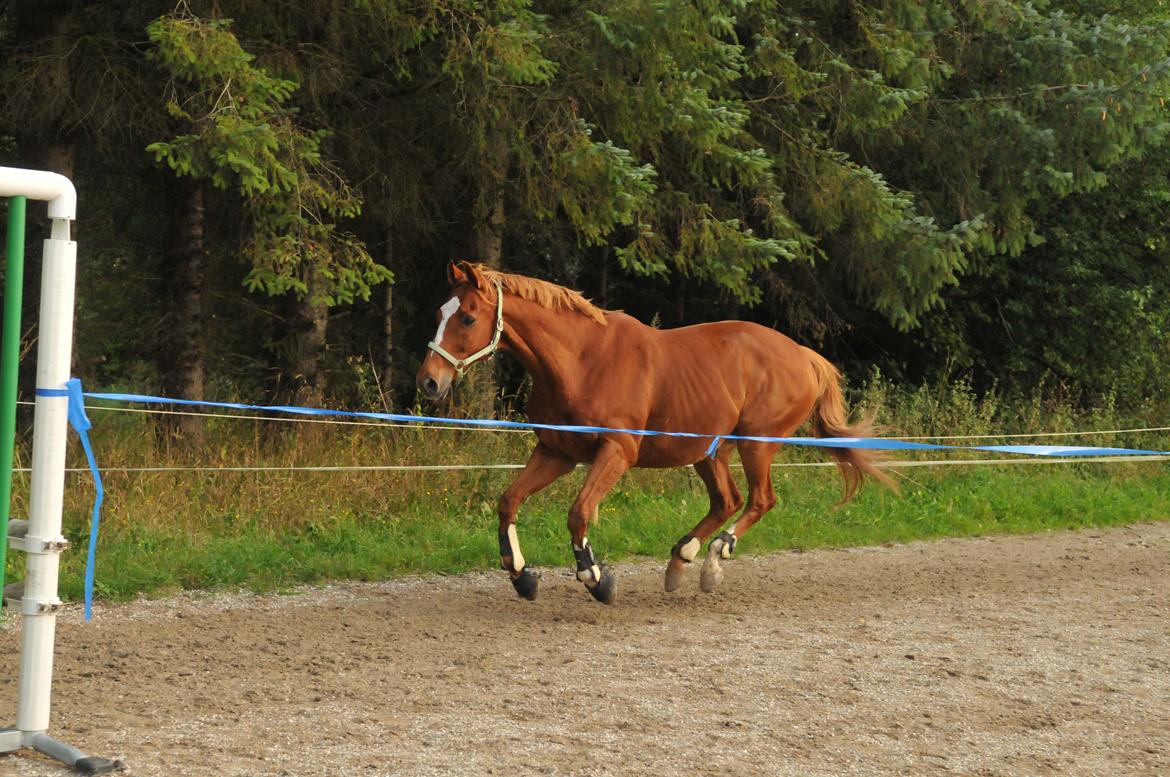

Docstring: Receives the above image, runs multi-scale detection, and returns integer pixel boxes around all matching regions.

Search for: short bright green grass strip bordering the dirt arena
[41,463,1170,599]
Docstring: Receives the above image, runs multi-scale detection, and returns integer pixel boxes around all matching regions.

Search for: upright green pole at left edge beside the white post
[0,197,26,598]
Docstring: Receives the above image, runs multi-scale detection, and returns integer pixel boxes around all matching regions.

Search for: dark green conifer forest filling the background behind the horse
[0,0,1170,421]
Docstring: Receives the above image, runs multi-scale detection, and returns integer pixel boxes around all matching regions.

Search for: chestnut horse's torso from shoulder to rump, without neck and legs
[529,312,815,467]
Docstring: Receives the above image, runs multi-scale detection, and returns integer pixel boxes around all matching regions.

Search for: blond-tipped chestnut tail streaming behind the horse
[804,348,897,504]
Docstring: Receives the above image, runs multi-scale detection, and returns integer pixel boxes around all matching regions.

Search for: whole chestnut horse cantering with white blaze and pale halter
[418,262,890,604]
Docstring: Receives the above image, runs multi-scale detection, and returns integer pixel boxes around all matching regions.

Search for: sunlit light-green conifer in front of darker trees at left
[147,9,391,403]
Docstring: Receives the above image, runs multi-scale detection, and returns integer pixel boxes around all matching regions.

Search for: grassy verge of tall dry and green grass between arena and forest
[8,377,1170,600]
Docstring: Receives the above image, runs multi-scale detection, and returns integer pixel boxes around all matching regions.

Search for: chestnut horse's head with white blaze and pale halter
[415,262,503,399]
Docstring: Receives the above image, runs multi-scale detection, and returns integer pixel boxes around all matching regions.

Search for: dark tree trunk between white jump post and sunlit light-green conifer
[160,181,206,445]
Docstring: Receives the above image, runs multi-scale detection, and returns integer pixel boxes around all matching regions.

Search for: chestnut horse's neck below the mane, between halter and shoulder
[504,296,605,396]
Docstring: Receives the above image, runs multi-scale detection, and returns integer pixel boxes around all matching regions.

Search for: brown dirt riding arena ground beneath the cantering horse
[0,523,1170,777]
